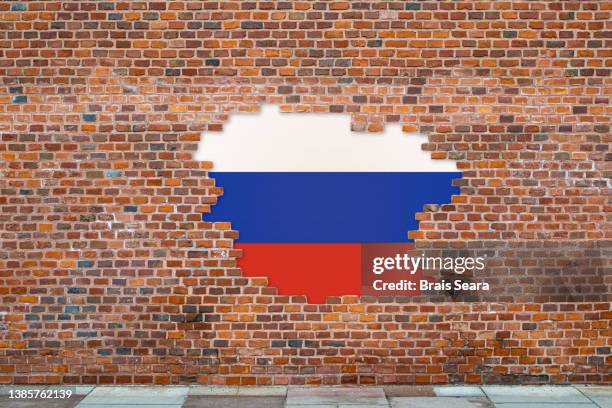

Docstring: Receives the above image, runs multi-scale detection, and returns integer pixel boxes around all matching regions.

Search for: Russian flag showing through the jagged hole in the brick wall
[197,107,460,303]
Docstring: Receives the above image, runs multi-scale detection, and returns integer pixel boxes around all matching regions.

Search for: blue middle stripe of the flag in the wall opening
[202,172,461,243]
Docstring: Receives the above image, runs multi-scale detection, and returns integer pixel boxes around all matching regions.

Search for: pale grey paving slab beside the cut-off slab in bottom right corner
[482,385,590,405]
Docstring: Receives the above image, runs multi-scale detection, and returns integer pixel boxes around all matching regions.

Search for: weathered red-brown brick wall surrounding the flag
[0,1,612,385]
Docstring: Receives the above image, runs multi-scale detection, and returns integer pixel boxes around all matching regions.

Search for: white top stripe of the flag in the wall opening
[196,105,457,172]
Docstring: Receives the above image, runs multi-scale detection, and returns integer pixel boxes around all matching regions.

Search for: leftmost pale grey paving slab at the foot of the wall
[79,386,189,407]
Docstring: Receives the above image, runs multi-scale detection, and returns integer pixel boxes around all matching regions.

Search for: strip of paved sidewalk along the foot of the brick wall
[0,385,612,408]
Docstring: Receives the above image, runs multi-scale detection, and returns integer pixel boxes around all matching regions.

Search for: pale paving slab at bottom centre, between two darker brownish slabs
[287,387,387,406]
